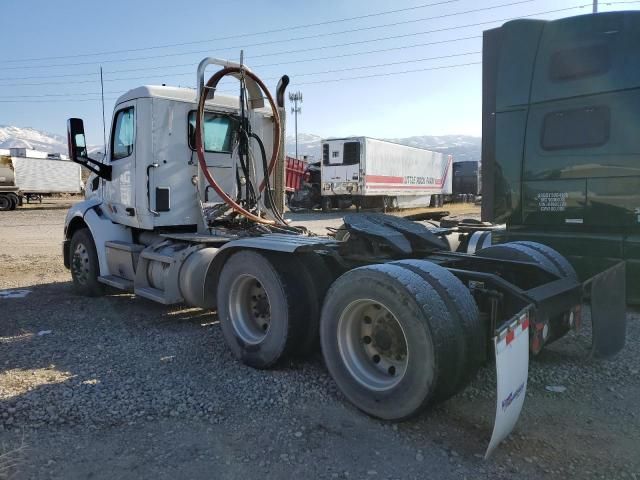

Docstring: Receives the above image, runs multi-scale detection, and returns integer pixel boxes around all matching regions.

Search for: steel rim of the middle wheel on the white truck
[229,274,271,344]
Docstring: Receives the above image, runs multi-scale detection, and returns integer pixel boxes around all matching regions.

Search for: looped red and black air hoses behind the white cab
[196,66,287,227]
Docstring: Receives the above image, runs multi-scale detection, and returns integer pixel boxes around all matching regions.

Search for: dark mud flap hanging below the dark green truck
[584,262,627,358]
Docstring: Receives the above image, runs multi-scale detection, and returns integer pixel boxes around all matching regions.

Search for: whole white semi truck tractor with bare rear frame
[63,58,624,452]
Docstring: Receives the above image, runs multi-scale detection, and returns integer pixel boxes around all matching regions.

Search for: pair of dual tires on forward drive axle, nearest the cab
[217,251,332,369]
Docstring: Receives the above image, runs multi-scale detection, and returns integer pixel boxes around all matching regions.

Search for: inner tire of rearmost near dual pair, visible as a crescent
[393,260,487,401]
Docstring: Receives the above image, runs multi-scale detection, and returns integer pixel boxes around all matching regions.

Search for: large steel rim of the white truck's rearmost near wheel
[337,299,409,391]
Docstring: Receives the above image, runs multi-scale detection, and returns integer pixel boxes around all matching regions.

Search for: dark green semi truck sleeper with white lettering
[482,12,640,304]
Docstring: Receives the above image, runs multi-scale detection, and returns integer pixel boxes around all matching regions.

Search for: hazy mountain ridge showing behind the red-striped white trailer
[285,133,481,162]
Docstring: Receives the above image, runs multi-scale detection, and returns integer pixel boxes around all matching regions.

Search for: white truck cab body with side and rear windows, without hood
[77,86,271,231]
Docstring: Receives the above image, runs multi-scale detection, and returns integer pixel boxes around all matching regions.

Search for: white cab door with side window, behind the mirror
[104,100,139,227]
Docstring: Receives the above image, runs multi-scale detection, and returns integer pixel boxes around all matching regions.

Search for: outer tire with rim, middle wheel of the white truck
[217,251,304,368]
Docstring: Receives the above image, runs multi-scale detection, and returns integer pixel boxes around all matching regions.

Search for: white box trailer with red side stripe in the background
[321,137,453,210]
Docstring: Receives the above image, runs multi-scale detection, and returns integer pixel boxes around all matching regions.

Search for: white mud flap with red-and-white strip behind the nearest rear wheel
[484,307,529,458]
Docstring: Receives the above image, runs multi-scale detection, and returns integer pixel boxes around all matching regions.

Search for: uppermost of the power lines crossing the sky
[0,0,462,63]
